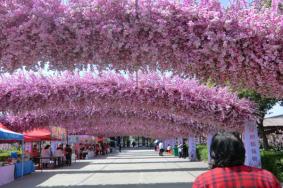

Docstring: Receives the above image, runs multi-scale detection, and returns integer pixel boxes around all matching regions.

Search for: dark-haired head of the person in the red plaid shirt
[210,132,245,168]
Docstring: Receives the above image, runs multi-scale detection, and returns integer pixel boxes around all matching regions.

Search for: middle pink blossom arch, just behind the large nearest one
[0,73,255,130]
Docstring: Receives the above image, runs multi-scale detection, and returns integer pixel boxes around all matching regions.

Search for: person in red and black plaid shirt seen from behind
[193,132,281,188]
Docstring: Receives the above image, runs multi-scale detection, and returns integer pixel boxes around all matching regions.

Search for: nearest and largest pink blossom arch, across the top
[0,0,283,98]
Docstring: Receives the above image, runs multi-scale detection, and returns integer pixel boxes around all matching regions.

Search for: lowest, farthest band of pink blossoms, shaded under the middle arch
[6,108,227,136]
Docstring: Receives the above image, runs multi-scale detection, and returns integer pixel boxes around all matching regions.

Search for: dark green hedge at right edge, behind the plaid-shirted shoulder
[261,150,283,181]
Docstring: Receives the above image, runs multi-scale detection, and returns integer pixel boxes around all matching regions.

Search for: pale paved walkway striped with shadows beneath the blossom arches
[1,150,207,188]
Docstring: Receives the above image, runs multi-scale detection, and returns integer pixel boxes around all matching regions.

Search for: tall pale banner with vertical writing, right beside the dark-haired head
[243,121,261,168]
